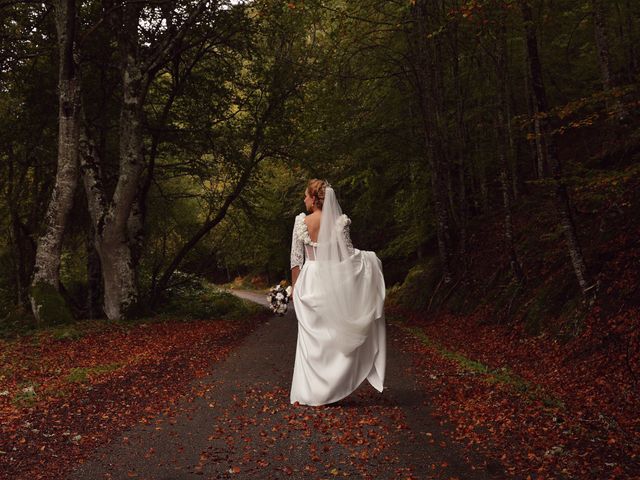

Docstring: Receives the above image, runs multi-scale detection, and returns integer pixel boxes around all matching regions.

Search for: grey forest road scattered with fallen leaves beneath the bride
[68,291,498,480]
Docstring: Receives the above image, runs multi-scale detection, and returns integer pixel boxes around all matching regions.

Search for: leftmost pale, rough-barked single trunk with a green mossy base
[30,0,80,323]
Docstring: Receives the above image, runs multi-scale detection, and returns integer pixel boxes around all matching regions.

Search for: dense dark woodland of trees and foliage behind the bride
[0,0,640,322]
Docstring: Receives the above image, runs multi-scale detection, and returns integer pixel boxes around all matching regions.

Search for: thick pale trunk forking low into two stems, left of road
[81,0,208,320]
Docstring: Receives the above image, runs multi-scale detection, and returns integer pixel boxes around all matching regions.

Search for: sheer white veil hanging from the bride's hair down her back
[314,184,384,354]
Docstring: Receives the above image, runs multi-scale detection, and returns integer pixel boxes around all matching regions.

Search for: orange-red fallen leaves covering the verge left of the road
[0,319,260,480]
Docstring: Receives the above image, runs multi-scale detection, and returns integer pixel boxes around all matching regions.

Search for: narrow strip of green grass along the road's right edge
[400,326,564,409]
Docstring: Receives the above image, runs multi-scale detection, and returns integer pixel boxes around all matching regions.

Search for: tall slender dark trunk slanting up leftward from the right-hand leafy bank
[520,0,594,296]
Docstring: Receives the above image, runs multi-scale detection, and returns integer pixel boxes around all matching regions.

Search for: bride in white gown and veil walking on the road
[291,179,386,405]
